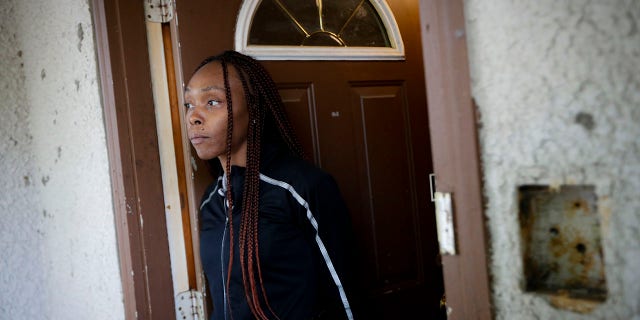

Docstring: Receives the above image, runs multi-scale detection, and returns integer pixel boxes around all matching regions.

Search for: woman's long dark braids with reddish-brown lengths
[194,51,303,319]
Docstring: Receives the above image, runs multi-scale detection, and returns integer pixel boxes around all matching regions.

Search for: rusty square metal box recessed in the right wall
[518,185,607,310]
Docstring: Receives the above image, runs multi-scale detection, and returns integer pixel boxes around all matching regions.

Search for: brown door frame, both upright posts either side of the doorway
[91,0,492,319]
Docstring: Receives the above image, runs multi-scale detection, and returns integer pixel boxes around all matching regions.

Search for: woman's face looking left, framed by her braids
[184,62,249,168]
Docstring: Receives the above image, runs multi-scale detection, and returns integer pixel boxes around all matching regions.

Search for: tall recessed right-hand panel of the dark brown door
[352,83,421,292]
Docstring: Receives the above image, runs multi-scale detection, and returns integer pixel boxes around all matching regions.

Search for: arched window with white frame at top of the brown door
[235,0,404,60]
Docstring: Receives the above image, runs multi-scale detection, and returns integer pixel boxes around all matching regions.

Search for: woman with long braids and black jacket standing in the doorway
[185,51,353,320]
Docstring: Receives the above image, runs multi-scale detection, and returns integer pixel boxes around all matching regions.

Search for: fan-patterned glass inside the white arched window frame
[248,0,391,47]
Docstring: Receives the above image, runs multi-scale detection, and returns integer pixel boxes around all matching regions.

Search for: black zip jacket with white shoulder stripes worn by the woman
[200,149,353,320]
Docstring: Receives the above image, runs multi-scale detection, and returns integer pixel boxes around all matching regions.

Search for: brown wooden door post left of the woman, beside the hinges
[91,0,176,319]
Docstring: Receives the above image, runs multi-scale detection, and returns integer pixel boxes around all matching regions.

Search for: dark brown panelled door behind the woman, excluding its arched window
[177,0,444,319]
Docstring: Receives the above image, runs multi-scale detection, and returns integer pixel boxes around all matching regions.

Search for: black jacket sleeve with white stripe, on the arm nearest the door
[308,174,360,319]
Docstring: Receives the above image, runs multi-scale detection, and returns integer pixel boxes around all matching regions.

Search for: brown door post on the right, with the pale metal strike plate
[420,0,493,319]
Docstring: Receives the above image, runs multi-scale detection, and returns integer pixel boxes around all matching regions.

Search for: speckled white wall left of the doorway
[0,0,124,319]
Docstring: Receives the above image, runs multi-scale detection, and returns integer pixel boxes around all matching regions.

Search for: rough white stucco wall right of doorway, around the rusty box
[465,0,640,320]
